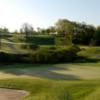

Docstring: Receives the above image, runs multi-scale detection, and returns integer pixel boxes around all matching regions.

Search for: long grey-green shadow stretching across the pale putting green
[0,64,81,80]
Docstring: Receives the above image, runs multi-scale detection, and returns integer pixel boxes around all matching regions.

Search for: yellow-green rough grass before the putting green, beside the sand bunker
[0,78,100,100]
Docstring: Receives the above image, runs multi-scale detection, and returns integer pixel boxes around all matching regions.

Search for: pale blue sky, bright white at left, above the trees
[0,0,100,31]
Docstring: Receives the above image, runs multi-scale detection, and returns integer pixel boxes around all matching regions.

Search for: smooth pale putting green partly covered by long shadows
[0,63,100,80]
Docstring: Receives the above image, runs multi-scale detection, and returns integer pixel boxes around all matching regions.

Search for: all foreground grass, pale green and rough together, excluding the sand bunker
[0,63,100,100]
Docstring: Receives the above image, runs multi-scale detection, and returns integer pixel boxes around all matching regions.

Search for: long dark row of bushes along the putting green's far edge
[0,46,79,63]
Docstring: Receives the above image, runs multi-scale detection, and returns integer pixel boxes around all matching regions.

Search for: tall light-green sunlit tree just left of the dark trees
[55,19,73,44]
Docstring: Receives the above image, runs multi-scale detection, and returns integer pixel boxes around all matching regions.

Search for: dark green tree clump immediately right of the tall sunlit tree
[73,23,95,45]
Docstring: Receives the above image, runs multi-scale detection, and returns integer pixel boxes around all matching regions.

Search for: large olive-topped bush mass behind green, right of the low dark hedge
[31,46,79,63]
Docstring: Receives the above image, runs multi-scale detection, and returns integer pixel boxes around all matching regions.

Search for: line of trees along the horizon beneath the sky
[0,19,100,45]
